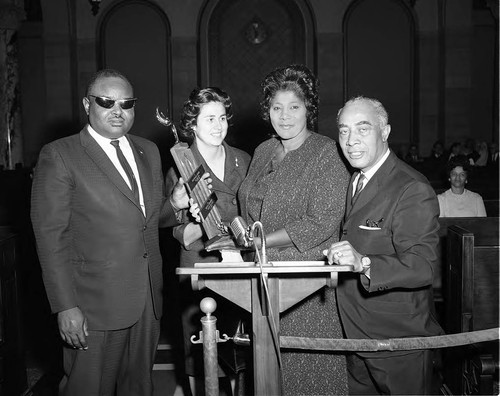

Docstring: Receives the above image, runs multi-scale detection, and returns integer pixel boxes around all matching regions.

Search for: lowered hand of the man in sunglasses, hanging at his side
[57,307,89,350]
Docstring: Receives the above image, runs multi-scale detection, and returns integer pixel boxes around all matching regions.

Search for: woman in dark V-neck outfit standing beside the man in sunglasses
[167,87,250,395]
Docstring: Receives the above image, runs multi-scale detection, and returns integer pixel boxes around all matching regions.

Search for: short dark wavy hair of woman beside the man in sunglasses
[179,87,233,144]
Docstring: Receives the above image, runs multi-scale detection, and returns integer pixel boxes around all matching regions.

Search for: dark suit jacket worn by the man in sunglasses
[31,128,176,330]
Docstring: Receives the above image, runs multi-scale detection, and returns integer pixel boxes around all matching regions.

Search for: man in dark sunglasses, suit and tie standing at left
[31,69,187,396]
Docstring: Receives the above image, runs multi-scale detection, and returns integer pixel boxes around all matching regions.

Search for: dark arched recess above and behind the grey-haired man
[343,0,418,151]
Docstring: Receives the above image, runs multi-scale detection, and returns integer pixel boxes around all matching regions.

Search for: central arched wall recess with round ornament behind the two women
[202,0,306,153]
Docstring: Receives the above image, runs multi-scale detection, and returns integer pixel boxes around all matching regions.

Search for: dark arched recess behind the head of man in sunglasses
[98,0,173,168]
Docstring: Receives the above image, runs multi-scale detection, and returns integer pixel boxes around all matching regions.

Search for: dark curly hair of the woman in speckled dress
[260,65,319,130]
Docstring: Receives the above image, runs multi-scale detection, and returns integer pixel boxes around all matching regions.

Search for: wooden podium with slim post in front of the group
[176,261,352,396]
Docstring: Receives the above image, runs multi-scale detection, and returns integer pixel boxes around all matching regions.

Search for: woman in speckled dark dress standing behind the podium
[238,65,349,395]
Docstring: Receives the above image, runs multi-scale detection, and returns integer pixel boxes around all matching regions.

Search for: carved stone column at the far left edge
[0,0,24,169]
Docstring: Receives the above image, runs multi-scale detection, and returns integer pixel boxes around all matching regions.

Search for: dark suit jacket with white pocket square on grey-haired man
[337,153,442,356]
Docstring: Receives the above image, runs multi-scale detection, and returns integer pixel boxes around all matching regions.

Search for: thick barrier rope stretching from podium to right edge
[280,327,500,352]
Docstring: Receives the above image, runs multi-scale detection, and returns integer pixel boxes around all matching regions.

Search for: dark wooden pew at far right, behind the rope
[443,218,500,395]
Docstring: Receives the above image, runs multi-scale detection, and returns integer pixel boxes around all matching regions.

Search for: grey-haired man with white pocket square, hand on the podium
[325,97,442,395]
